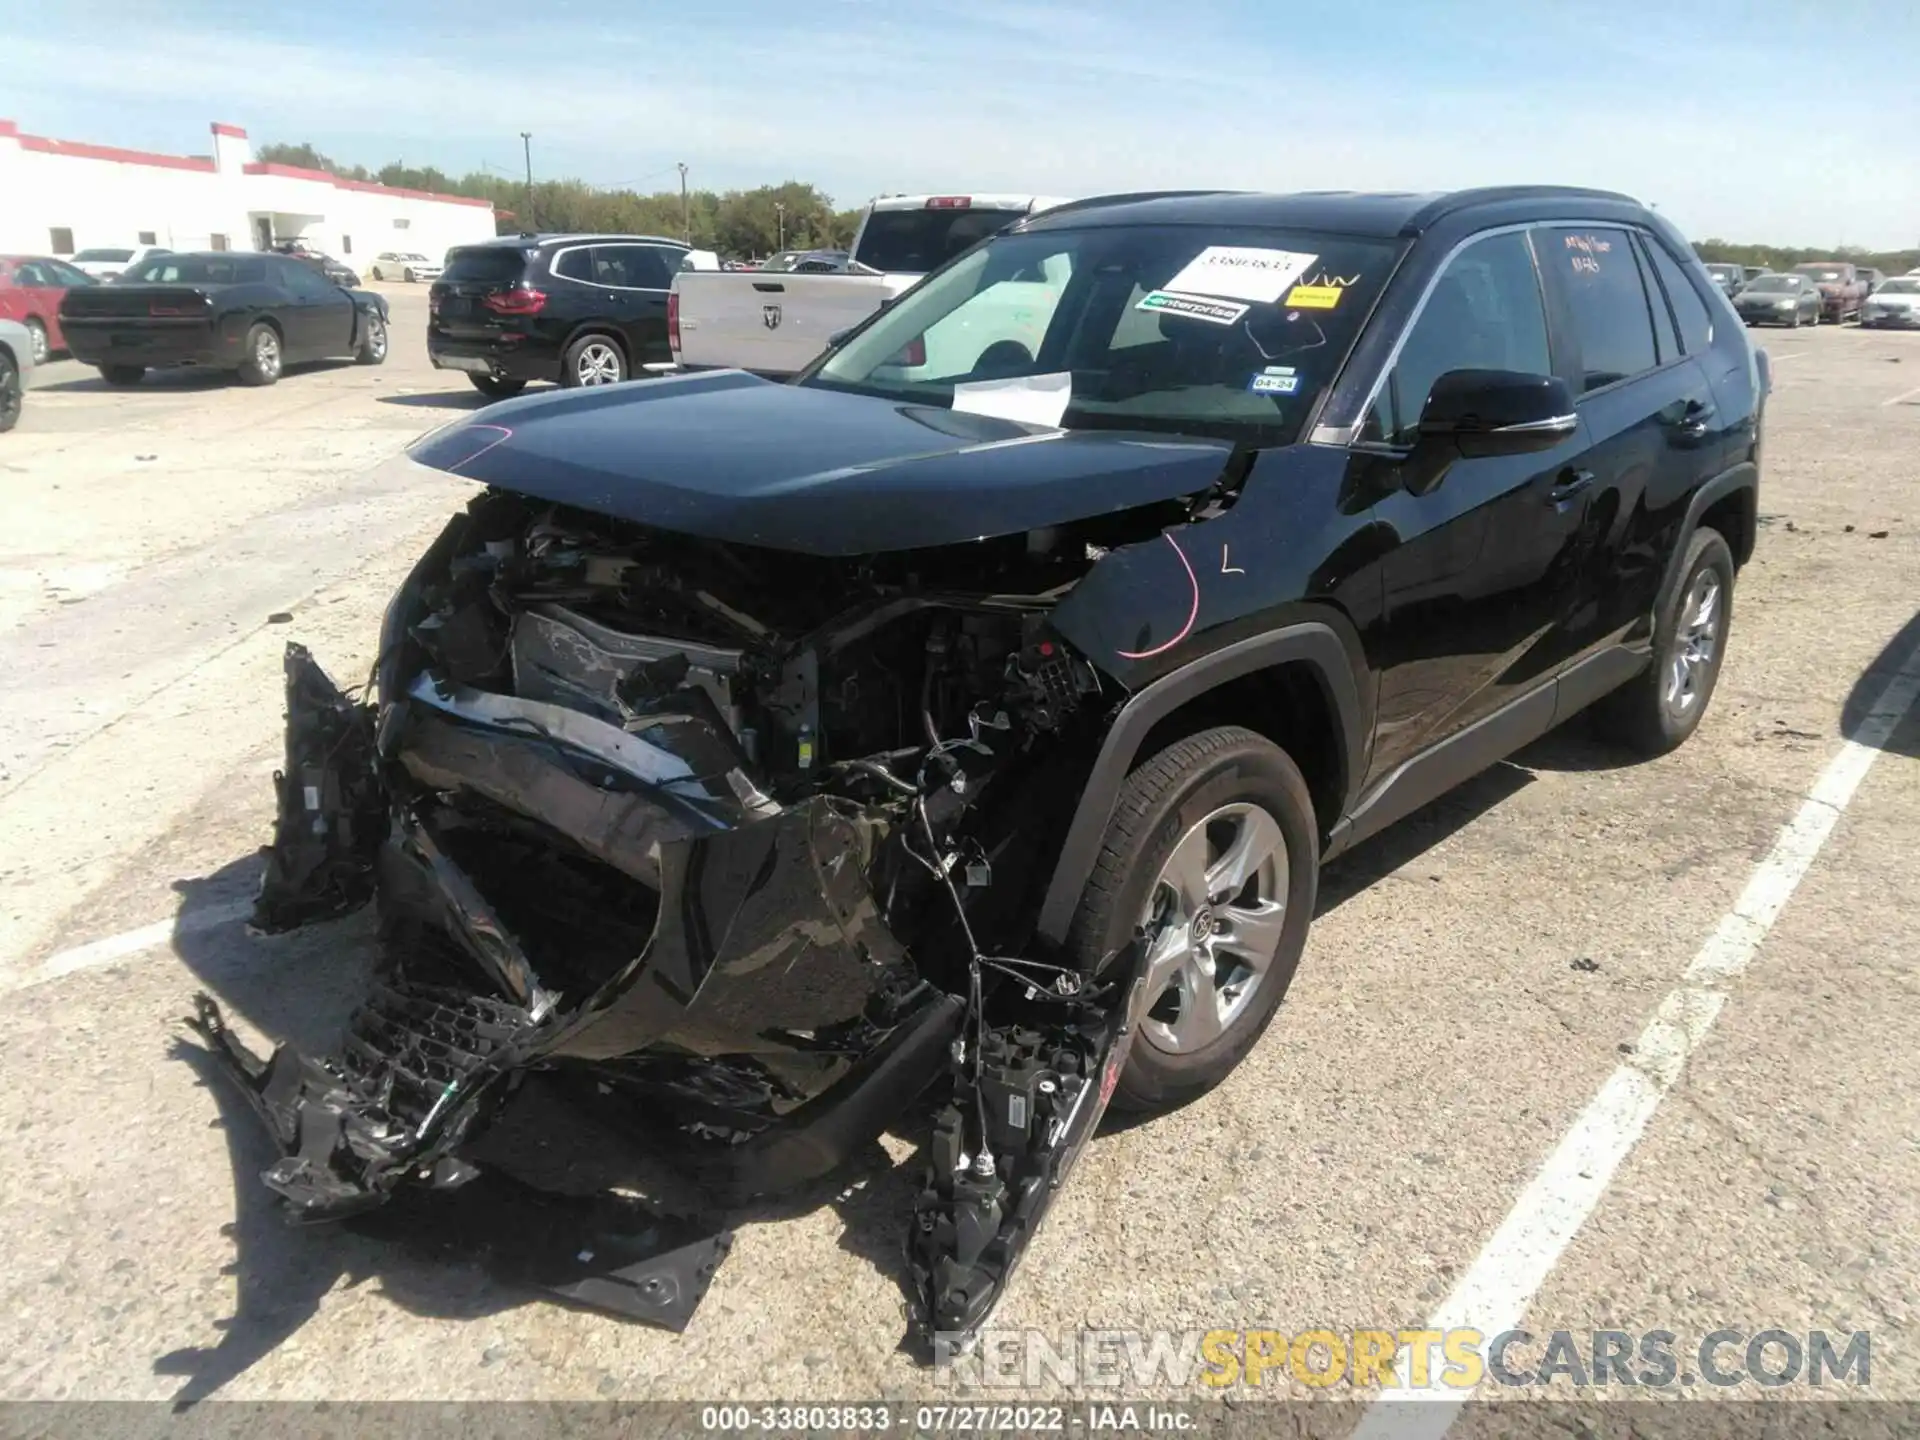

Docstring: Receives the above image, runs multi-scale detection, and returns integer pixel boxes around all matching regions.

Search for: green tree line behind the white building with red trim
[255,144,864,259]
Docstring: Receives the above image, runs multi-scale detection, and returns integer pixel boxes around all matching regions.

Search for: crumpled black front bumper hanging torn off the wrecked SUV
[190,645,1139,1346]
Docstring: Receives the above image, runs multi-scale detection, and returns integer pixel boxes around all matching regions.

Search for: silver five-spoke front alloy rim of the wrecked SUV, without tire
[1140,803,1288,1054]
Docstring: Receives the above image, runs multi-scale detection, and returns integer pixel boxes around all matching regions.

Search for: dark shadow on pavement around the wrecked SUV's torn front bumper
[154,856,925,1409]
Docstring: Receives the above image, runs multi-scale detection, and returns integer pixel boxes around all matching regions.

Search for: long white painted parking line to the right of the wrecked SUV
[1354,641,1920,1440]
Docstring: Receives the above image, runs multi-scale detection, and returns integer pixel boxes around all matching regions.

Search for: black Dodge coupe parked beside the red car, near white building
[60,250,388,386]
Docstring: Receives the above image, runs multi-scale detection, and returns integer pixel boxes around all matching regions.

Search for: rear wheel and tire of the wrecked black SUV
[1594,526,1734,756]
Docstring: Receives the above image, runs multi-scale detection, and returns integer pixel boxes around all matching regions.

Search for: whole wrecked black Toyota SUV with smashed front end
[198,188,1766,1340]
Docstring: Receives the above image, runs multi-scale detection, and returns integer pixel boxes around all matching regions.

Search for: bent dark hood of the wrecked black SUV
[409,371,1231,557]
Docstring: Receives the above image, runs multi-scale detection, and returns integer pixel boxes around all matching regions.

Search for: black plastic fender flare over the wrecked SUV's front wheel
[1037,620,1365,945]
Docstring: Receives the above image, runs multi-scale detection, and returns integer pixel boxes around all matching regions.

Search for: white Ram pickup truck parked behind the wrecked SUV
[666,196,1068,378]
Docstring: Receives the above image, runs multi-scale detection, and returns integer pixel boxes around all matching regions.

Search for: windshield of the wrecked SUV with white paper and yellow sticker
[801,225,1398,445]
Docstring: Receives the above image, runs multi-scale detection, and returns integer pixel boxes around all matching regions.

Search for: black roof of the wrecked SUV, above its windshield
[1020,184,1644,240]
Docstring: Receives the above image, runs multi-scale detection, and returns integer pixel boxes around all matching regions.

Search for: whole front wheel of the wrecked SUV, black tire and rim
[1068,726,1319,1112]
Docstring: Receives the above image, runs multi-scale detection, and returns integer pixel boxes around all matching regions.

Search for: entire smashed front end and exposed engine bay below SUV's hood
[196,490,1152,1340]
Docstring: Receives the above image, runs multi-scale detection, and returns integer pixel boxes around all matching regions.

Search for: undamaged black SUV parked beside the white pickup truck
[426,234,687,399]
